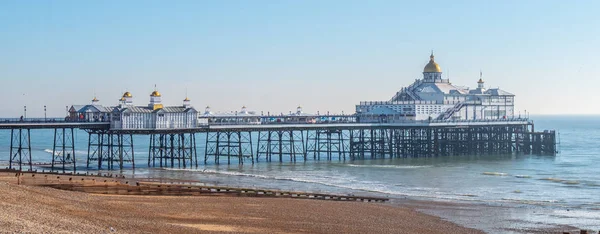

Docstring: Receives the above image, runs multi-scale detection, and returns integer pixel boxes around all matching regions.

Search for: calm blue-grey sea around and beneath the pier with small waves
[0,115,600,233]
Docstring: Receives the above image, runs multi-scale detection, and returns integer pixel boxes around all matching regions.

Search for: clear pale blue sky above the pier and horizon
[0,0,600,117]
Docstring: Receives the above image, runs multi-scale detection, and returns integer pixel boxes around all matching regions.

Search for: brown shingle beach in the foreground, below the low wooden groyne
[0,177,482,233]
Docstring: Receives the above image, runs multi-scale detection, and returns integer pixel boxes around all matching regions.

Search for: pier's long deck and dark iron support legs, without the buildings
[0,116,556,172]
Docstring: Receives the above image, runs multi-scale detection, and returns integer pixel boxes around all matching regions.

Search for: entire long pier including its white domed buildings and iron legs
[0,52,556,172]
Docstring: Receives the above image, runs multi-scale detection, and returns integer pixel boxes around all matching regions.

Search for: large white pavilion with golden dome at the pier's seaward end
[356,52,515,123]
